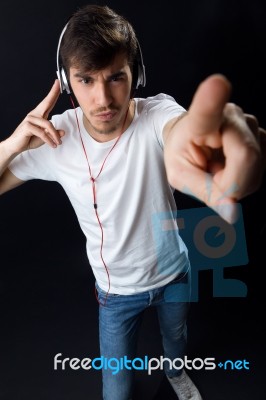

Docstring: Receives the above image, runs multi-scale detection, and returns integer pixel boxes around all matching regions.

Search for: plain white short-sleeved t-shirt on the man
[9,94,188,294]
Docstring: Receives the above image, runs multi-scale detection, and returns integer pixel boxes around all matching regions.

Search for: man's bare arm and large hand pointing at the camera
[164,75,266,222]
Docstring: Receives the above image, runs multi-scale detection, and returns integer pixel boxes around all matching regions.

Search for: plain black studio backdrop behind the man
[0,0,266,400]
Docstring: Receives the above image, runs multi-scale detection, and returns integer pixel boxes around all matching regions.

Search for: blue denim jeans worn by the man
[96,270,190,400]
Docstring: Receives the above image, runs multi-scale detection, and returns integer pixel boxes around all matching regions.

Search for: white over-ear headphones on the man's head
[56,23,146,94]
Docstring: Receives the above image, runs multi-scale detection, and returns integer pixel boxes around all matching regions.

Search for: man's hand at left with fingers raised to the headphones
[5,79,65,154]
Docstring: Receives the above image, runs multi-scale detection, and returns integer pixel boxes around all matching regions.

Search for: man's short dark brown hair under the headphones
[60,5,138,75]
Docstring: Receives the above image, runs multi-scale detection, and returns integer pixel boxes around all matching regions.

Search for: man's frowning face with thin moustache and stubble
[70,54,133,141]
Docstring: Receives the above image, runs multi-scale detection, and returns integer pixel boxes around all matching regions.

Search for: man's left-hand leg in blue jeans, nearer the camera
[98,282,147,400]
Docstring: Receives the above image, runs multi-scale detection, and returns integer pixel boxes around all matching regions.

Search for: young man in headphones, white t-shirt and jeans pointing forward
[0,5,265,400]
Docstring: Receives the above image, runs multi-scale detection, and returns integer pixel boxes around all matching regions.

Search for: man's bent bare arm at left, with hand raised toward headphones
[0,80,64,195]
